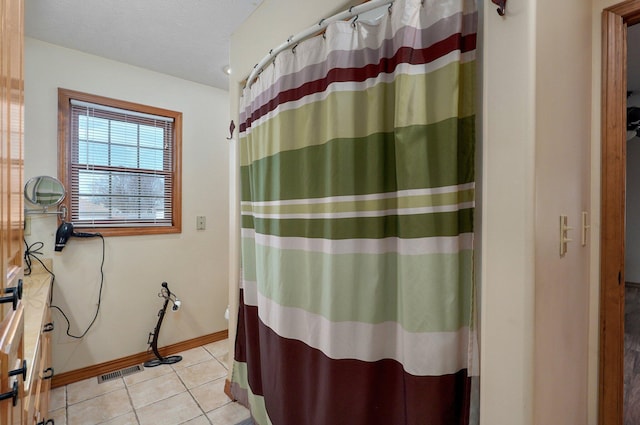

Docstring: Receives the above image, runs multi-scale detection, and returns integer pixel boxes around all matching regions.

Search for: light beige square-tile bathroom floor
[49,340,249,425]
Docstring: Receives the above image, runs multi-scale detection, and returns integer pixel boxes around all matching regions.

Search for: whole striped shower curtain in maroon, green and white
[231,0,477,425]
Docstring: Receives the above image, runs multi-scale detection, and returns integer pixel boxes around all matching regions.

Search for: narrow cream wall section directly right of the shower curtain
[478,0,536,425]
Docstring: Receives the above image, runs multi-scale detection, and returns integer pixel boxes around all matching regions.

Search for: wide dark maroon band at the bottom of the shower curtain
[235,292,471,425]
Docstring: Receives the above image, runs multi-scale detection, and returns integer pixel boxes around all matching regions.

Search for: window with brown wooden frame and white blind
[58,89,182,236]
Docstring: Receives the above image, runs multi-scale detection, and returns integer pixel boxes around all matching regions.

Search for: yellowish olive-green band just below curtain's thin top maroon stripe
[241,62,475,165]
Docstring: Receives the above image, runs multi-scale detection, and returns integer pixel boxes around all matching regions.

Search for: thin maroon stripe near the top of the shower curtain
[240,33,476,132]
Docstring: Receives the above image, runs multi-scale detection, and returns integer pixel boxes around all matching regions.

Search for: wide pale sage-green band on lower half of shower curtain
[243,247,473,332]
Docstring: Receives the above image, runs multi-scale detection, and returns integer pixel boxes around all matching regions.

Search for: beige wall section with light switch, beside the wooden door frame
[534,0,592,425]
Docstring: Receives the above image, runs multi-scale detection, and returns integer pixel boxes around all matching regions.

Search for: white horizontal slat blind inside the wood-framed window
[69,99,174,227]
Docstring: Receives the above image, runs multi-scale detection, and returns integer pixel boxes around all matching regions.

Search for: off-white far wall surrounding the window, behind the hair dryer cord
[25,39,229,373]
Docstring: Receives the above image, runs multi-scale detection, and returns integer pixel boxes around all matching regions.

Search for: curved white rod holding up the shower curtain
[246,0,394,87]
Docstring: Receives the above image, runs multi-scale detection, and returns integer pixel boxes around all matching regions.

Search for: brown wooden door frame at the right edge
[598,0,640,425]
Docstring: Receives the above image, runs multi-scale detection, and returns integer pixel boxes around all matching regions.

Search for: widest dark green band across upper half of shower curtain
[240,117,475,202]
